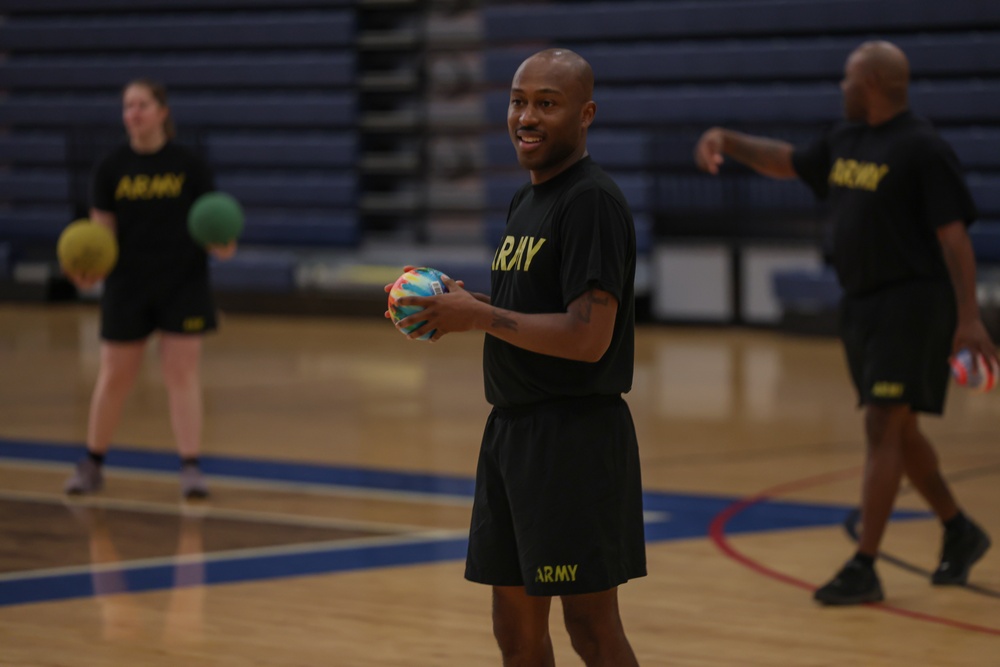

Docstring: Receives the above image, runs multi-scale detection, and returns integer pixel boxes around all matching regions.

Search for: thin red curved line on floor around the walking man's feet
[708,468,1000,637]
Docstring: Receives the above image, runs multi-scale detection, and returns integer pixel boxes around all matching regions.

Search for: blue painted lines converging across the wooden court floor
[0,439,930,606]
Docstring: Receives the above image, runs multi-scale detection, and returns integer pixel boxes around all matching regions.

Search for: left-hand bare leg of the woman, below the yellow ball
[87,341,146,454]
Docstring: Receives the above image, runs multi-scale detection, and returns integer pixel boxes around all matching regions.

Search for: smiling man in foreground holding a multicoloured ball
[386,49,646,667]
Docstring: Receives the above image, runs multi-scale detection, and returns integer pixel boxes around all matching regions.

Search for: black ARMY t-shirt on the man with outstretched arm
[792,111,976,295]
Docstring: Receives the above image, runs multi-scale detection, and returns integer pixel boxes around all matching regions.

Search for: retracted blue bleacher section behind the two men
[483,0,1000,323]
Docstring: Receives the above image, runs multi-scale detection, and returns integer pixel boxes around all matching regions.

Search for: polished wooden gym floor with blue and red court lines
[0,304,1000,667]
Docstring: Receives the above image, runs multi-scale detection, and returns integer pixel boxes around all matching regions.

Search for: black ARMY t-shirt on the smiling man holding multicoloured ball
[483,157,636,407]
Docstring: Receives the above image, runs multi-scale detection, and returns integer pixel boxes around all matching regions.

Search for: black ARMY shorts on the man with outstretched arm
[841,281,956,414]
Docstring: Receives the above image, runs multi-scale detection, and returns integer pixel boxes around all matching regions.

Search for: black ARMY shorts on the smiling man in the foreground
[465,396,646,595]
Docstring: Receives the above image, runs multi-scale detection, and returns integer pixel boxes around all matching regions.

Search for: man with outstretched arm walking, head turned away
[695,41,996,605]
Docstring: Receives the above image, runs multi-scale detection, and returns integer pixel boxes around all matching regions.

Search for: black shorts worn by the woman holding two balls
[101,274,218,342]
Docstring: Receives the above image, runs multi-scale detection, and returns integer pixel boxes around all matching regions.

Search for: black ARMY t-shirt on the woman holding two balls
[93,142,215,278]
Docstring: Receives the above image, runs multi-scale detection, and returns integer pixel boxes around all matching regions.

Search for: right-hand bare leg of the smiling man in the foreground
[562,588,639,667]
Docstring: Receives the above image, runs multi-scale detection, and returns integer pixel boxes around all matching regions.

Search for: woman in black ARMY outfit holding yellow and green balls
[65,79,236,498]
